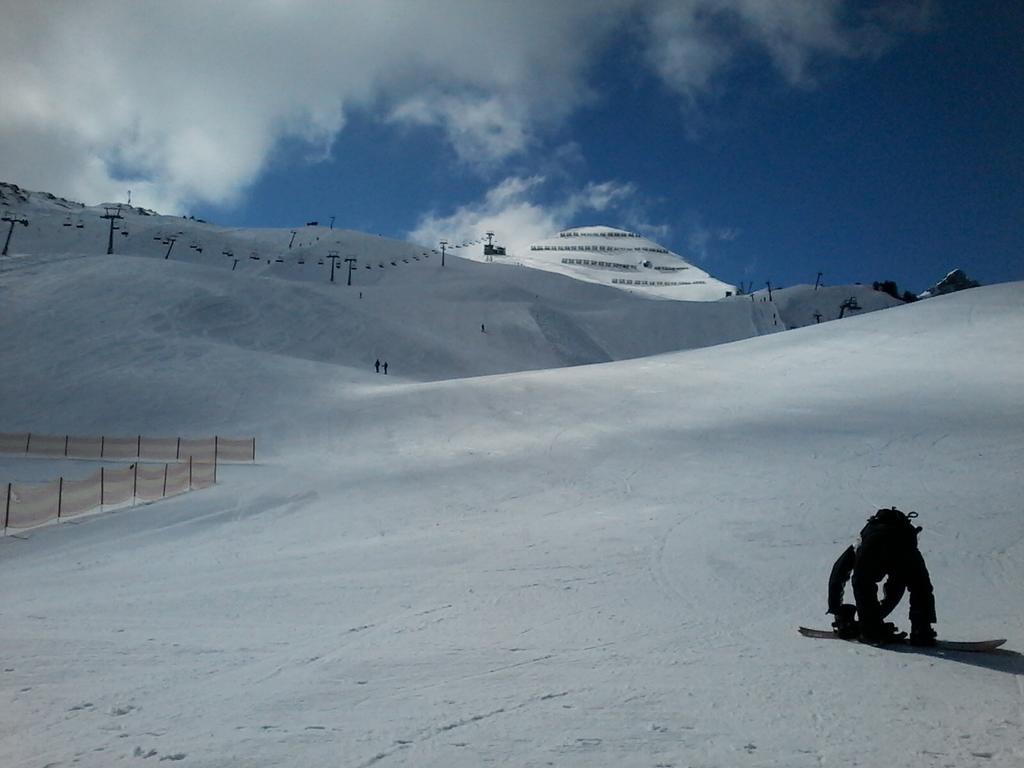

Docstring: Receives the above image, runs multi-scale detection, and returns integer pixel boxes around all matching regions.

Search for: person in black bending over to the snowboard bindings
[828,507,936,645]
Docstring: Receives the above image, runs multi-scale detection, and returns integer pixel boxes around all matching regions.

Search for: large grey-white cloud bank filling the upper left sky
[0,0,922,211]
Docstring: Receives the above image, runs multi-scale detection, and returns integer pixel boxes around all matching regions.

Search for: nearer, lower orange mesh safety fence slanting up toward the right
[0,454,217,535]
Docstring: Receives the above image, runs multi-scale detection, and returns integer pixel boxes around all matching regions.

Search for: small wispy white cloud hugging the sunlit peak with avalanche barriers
[409,176,634,256]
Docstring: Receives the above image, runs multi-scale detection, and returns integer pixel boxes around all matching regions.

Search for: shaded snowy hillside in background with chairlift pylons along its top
[0,185,899,380]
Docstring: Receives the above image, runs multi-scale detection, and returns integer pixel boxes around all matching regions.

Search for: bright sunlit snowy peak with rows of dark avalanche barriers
[519,226,736,301]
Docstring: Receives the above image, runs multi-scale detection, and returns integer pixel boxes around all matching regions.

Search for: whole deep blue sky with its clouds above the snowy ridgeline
[0,0,1024,291]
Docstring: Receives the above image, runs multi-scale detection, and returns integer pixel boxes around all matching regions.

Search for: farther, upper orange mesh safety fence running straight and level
[0,432,256,462]
